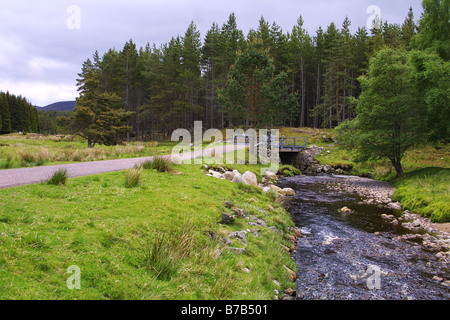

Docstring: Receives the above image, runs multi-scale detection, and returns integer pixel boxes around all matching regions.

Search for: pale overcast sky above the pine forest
[0,0,422,106]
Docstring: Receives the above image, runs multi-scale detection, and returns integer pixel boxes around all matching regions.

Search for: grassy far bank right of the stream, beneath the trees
[280,128,450,223]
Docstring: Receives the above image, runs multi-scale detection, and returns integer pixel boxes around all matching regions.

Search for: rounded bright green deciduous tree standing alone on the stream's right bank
[338,49,423,175]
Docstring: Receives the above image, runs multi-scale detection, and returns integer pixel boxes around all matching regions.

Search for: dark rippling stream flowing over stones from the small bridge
[278,175,450,300]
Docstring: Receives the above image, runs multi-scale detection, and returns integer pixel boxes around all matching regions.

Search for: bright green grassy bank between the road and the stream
[0,158,295,299]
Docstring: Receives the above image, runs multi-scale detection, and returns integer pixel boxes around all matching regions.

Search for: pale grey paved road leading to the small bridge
[0,145,246,189]
